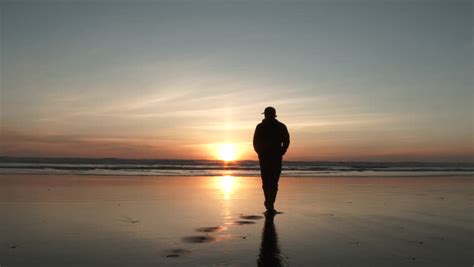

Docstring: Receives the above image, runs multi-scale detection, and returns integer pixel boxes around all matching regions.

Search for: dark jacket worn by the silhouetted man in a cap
[253,119,290,158]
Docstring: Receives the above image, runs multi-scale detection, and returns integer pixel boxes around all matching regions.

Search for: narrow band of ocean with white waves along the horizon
[0,157,474,177]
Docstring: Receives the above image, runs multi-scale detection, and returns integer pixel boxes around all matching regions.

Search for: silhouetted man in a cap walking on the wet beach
[253,107,290,213]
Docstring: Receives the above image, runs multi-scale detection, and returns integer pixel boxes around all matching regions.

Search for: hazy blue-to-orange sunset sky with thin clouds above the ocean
[0,0,474,162]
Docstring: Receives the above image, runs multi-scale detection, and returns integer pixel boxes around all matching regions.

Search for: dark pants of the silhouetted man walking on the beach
[259,156,282,210]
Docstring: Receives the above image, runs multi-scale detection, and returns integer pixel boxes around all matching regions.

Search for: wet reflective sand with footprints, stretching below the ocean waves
[0,175,474,267]
